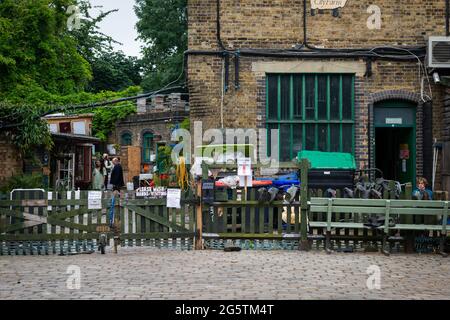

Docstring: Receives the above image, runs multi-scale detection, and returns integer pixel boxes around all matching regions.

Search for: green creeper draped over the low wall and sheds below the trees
[0,87,141,156]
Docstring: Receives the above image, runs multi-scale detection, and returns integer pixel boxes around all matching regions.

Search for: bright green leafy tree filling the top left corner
[0,0,91,98]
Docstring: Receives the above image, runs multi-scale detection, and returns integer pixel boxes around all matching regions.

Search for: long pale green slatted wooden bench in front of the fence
[310,198,449,255]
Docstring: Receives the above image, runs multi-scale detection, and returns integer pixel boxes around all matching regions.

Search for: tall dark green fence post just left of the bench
[299,159,311,251]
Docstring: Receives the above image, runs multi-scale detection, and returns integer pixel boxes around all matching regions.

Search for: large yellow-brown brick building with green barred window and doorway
[188,0,450,190]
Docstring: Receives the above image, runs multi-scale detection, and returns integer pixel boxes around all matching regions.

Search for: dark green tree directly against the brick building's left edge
[135,0,187,90]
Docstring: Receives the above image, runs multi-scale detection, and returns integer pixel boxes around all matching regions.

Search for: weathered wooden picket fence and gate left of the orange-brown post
[0,190,196,255]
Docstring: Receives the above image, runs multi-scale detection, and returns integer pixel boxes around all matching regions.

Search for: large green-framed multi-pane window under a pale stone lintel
[266,73,355,161]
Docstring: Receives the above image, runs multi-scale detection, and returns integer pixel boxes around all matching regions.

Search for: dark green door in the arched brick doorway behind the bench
[374,101,416,184]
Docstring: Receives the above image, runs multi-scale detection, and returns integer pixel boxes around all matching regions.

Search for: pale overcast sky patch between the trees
[90,0,143,57]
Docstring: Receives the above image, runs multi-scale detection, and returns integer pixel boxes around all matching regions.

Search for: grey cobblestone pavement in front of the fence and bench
[0,248,450,300]
